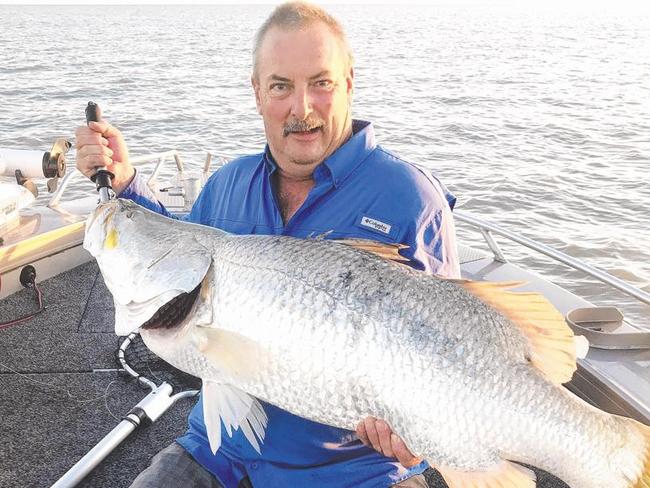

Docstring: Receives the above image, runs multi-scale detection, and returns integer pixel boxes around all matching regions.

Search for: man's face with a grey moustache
[252,22,353,173]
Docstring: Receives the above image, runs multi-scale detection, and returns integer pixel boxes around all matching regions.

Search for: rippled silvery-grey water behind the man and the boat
[0,5,650,327]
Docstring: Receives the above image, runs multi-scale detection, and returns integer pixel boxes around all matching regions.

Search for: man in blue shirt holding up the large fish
[77,3,459,488]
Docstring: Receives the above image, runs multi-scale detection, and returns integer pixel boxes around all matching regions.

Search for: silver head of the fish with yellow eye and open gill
[83,199,213,335]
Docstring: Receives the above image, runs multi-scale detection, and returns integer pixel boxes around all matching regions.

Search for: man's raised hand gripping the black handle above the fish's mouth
[75,120,135,195]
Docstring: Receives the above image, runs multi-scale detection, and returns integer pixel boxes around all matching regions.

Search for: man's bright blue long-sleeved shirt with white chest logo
[120,120,460,488]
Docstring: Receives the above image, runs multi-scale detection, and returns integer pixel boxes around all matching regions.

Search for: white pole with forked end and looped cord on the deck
[51,333,201,488]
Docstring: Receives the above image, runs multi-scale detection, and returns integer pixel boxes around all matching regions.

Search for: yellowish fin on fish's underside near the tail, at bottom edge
[436,461,536,488]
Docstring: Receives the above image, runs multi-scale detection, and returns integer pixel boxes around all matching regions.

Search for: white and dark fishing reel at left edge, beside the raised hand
[0,139,72,197]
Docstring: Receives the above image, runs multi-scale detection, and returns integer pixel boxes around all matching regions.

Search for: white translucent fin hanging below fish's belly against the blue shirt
[203,381,268,454]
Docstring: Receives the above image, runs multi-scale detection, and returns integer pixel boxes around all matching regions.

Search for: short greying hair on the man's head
[253,1,354,79]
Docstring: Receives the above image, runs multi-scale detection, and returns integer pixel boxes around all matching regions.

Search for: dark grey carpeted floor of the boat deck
[0,262,566,488]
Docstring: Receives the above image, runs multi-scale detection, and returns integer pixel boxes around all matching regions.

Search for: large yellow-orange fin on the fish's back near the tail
[459,281,577,384]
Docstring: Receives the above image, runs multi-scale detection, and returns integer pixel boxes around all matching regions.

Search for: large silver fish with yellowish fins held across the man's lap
[84,200,650,488]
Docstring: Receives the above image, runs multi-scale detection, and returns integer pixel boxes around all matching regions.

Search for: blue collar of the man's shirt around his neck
[263,120,377,186]
